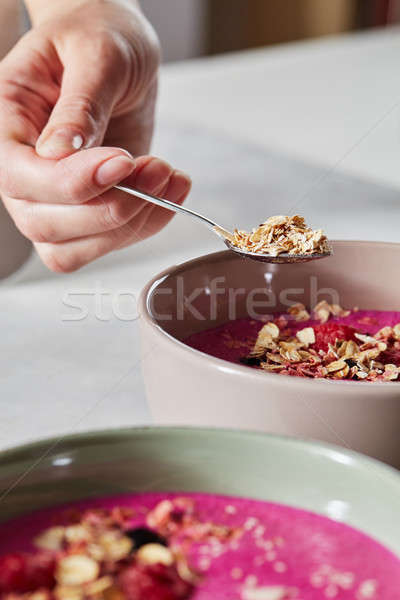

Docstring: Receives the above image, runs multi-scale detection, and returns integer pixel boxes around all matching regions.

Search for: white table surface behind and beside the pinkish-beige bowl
[0,29,400,448]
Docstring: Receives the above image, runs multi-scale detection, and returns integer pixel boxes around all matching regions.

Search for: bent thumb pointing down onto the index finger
[36,34,127,159]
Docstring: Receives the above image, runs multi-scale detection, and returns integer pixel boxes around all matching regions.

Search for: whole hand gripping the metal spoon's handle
[0,0,190,272]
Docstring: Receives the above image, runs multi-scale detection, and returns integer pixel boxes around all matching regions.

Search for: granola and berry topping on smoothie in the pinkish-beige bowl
[244,300,400,381]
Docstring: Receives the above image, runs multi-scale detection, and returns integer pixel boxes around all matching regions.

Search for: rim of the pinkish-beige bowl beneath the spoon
[138,240,400,396]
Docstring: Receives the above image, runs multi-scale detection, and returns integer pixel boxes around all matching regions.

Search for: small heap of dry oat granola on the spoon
[232,215,330,256]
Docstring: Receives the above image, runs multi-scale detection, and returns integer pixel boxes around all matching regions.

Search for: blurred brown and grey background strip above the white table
[141,0,400,62]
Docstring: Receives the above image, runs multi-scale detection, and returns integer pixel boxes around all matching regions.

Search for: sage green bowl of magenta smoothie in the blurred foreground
[0,428,400,600]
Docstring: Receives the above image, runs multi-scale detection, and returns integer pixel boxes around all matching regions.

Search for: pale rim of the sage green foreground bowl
[0,425,400,486]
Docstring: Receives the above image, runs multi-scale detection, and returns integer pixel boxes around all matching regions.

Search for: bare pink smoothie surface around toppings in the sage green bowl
[0,494,400,600]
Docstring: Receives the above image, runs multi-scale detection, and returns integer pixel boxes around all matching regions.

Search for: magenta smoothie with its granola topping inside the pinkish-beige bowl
[186,300,400,382]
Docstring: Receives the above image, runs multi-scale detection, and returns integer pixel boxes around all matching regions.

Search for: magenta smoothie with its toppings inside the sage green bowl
[0,494,400,600]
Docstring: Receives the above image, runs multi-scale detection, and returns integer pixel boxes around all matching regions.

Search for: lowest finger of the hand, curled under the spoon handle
[35,161,191,273]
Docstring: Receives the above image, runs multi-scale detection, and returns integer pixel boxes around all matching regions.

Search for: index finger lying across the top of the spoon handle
[0,141,135,204]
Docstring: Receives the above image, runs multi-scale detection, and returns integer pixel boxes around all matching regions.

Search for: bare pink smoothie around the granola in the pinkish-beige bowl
[185,310,400,366]
